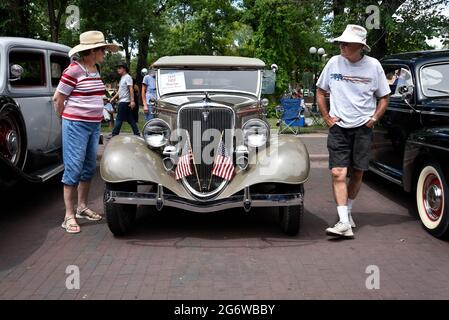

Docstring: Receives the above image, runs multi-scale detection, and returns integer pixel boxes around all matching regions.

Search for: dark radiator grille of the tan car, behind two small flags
[178,107,234,197]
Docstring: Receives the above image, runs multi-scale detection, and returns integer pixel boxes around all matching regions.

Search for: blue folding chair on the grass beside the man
[276,98,304,134]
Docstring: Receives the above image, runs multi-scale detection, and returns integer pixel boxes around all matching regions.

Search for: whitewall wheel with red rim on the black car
[416,162,449,238]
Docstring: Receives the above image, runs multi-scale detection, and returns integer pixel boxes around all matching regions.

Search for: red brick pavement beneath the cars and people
[0,134,449,299]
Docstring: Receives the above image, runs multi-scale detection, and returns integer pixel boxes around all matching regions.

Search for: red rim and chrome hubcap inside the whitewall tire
[423,174,443,221]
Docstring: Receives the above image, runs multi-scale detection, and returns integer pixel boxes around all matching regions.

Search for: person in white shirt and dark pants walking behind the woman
[110,62,140,136]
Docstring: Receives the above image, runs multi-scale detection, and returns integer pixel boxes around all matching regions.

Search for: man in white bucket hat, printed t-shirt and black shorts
[317,24,390,238]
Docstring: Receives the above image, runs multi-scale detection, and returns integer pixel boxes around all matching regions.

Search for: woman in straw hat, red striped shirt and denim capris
[53,31,118,233]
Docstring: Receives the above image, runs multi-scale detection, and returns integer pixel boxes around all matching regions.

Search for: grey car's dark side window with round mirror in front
[9,51,47,87]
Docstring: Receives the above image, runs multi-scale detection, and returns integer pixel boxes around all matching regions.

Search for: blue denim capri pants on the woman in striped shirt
[62,119,101,186]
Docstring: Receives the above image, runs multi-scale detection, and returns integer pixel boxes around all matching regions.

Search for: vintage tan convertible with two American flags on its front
[100,56,310,235]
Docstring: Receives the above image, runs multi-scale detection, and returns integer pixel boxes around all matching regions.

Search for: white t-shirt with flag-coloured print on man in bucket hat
[317,55,390,128]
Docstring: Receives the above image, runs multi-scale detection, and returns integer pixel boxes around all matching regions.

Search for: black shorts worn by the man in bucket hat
[327,124,373,171]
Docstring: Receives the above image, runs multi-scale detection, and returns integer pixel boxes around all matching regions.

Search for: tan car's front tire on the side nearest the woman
[103,181,137,236]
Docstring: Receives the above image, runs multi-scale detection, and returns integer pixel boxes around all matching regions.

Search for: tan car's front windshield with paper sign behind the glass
[158,69,259,96]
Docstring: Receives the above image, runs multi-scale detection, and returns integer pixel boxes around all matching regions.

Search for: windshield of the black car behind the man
[421,64,449,97]
